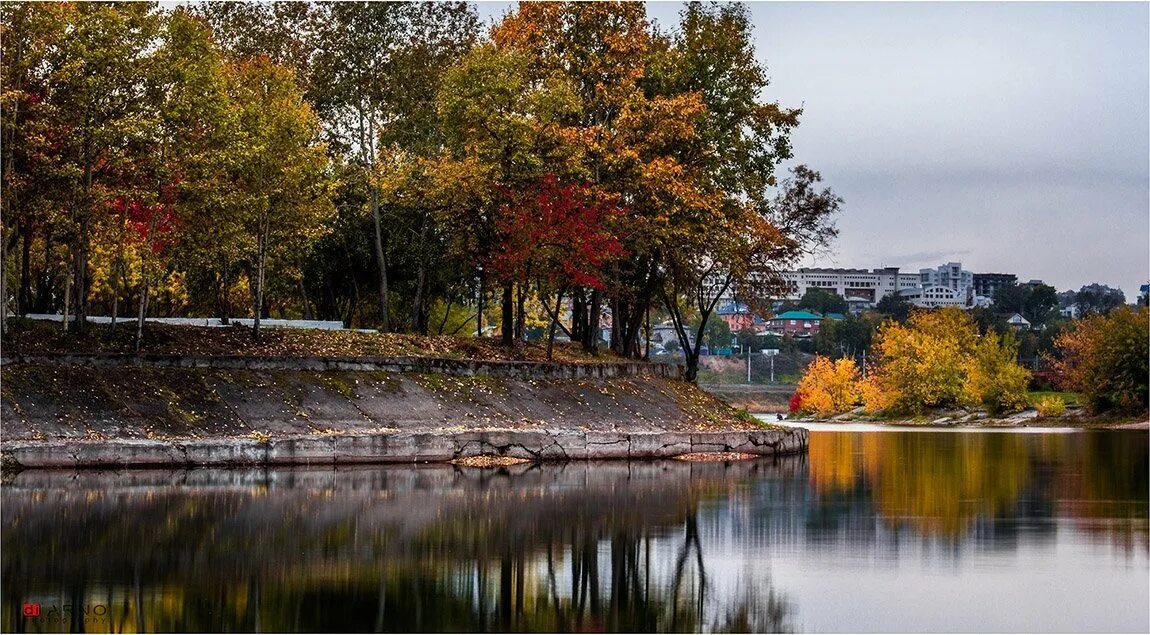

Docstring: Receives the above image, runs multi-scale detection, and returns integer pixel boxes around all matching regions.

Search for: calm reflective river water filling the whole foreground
[0,431,1150,633]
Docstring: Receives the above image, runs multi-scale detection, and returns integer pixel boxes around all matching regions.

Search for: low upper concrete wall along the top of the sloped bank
[0,353,683,380]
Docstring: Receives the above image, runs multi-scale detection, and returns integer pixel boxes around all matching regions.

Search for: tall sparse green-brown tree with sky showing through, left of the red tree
[309,2,477,331]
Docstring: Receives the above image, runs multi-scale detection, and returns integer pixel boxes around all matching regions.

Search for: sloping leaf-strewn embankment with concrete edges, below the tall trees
[0,350,806,467]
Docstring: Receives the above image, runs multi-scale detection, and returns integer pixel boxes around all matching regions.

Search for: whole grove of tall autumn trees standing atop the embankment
[0,2,841,375]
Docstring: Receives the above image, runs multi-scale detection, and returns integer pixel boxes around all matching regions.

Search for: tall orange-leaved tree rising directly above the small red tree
[492,2,657,354]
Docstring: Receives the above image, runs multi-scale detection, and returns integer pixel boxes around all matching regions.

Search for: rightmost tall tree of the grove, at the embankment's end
[659,2,842,378]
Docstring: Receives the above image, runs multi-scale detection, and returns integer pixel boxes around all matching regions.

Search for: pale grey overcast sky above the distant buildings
[478,2,1150,301]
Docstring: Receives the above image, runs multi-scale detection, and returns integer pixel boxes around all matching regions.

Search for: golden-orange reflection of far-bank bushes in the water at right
[810,430,1150,551]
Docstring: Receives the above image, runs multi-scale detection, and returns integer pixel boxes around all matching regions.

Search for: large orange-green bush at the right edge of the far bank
[1053,306,1150,414]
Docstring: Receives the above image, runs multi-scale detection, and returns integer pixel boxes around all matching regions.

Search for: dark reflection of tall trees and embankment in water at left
[2,461,787,632]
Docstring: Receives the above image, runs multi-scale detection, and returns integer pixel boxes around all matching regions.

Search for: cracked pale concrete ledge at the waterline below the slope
[2,428,807,468]
